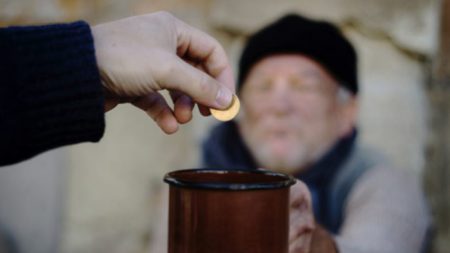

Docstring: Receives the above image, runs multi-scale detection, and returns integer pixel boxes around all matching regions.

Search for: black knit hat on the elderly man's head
[238,14,358,94]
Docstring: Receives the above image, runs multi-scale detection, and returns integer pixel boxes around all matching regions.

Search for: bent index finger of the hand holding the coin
[176,20,235,93]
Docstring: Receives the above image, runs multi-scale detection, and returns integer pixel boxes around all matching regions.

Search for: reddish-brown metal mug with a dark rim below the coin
[164,169,295,253]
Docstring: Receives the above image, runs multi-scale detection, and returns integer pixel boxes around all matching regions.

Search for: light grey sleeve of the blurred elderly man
[336,167,430,253]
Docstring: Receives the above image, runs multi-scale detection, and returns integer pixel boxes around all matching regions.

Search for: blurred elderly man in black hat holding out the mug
[203,15,429,253]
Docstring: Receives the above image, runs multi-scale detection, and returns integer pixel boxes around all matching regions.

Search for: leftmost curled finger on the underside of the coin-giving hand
[132,93,178,134]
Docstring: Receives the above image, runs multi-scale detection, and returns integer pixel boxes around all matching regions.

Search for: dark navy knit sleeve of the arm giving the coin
[0,21,105,165]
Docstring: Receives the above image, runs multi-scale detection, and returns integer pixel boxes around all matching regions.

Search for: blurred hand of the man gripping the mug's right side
[289,180,315,253]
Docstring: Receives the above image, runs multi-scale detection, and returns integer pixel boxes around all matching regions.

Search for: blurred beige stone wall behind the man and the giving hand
[0,0,450,253]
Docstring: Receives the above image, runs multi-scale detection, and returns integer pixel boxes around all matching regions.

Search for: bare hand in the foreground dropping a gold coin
[92,12,234,133]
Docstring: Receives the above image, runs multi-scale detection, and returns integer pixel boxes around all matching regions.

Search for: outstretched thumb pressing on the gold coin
[156,57,233,109]
